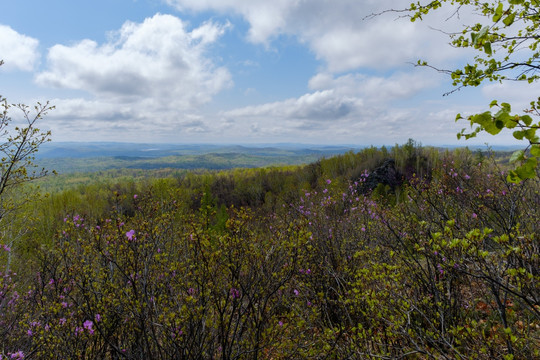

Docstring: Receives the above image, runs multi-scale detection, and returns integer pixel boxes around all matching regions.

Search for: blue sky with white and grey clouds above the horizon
[0,0,539,146]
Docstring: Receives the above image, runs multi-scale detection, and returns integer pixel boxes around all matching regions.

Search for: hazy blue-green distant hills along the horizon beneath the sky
[32,142,515,174]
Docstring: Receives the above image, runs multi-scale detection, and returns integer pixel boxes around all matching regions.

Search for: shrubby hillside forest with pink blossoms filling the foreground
[0,141,540,360]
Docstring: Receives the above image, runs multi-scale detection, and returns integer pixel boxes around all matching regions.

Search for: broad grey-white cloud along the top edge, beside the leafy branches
[167,0,463,72]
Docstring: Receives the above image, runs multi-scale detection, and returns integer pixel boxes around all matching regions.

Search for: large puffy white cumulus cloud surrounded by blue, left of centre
[36,14,231,110]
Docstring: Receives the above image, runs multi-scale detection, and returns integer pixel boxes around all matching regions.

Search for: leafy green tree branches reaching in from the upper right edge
[378,0,540,182]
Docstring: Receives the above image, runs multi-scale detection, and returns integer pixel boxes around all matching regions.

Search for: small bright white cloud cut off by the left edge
[0,24,40,71]
